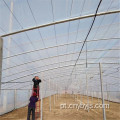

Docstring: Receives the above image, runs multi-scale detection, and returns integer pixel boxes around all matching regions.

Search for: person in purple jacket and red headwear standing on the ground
[27,92,38,120]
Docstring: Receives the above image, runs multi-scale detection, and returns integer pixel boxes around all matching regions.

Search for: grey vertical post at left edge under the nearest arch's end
[0,37,3,90]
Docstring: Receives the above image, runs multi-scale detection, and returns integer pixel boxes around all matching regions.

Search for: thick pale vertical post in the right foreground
[99,63,106,120]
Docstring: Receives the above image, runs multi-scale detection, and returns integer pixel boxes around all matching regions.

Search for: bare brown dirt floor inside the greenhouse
[0,94,120,120]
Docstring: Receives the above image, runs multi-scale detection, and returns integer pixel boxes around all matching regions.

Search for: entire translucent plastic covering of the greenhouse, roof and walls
[0,0,120,114]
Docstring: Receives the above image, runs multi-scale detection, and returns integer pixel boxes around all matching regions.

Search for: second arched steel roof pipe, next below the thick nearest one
[2,48,120,71]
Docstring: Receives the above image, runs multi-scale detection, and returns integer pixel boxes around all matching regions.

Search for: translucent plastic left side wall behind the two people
[0,90,56,115]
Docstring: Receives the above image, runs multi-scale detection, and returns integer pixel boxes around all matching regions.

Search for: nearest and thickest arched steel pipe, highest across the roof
[1,10,120,37]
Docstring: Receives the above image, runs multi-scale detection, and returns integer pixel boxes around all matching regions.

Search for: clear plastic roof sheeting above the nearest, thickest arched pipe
[0,0,120,35]
